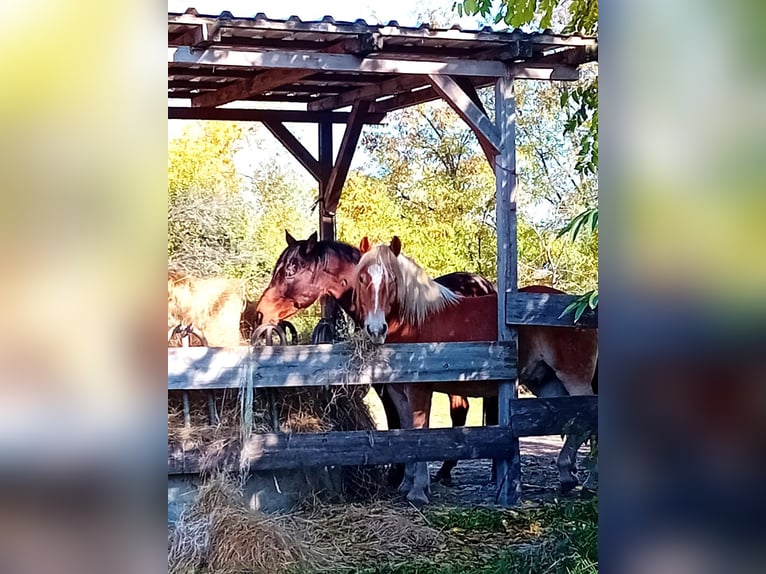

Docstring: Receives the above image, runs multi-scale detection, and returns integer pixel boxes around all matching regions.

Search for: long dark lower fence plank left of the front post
[168,427,513,474]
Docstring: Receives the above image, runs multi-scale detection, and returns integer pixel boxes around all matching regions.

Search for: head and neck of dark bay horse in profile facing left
[255,231,359,325]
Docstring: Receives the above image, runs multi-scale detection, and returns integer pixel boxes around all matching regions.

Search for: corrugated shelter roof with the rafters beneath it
[168,8,597,116]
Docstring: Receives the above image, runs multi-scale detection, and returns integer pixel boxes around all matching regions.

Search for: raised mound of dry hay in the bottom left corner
[168,474,322,574]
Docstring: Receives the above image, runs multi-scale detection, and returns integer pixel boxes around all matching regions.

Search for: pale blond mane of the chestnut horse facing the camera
[359,245,462,327]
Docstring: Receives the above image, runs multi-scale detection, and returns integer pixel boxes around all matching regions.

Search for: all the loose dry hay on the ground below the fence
[168,475,445,574]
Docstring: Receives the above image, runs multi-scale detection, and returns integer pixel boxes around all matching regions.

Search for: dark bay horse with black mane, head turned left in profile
[252,231,497,483]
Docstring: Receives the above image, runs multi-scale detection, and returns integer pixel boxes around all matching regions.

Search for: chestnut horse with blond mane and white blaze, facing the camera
[354,237,598,504]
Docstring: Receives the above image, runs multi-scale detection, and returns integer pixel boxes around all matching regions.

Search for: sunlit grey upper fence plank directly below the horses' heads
[168,342,516,390]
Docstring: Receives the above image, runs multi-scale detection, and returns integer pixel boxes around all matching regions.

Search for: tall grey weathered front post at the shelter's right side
[495,68,521,506]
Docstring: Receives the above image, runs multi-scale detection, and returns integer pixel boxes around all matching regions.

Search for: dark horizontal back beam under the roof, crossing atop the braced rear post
[168,106,385,124]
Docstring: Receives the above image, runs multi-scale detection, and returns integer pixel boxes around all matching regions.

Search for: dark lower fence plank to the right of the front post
[511,396,598,437]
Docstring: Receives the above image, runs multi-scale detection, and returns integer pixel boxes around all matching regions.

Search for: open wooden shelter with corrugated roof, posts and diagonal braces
[168,9,597,503]
